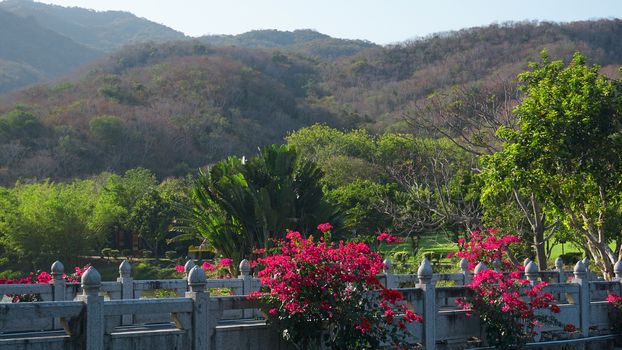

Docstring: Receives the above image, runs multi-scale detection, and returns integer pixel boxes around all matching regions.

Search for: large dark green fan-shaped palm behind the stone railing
[176,145,338,261]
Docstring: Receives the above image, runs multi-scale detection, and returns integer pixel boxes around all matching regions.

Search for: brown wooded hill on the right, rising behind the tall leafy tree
[315,19,622,130]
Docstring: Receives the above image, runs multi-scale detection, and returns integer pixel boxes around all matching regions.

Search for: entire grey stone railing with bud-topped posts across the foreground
[0,259,622,350]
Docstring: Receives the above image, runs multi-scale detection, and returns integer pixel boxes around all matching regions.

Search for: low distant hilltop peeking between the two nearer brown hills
[198,29,379,59]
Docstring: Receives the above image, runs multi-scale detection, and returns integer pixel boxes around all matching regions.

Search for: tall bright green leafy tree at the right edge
[484,52,622,277]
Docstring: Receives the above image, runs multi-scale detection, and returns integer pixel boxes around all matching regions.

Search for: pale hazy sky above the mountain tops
[36,0,622,44]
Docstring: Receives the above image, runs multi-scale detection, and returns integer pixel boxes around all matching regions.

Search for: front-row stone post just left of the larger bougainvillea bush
[186,263,213,350]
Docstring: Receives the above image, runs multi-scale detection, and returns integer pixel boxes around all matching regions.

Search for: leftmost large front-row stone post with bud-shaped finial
[77,266,104,350]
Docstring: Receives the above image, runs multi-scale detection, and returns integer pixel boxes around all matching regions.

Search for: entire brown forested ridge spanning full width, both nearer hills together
[0,20,622,184]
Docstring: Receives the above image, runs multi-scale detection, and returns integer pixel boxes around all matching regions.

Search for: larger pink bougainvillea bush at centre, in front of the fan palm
[249,227,422,349]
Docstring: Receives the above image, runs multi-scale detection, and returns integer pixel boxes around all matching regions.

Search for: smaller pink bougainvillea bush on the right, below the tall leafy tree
[455,229,561,349]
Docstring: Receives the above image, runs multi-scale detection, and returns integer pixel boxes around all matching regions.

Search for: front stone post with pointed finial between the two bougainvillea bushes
[417,258,436,350]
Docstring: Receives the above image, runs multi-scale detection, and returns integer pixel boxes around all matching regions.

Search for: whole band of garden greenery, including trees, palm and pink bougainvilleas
[0,52,622,349]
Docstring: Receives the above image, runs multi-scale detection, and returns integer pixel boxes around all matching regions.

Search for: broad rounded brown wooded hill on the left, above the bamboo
[0,41,344,184]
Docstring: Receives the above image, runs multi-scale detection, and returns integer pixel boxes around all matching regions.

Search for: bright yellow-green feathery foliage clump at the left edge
[0,180,105,268]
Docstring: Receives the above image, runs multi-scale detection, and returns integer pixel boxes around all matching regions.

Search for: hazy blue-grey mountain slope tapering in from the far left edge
[0,9,102,93]
